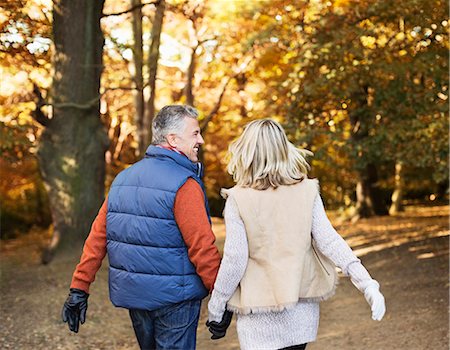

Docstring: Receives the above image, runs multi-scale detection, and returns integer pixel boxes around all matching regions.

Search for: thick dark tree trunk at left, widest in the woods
[39,0,107,263]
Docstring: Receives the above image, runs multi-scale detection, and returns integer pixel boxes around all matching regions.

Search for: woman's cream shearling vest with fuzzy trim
[223,179,337,314]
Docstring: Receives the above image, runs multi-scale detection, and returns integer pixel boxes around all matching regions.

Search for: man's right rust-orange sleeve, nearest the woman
[174,179,220,292]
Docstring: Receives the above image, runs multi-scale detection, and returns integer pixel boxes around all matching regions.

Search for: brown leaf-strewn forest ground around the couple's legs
[0,206,449,350]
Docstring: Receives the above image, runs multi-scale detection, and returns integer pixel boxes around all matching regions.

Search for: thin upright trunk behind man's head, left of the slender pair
[131,0,146,156]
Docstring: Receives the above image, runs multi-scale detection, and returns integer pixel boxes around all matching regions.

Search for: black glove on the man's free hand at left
[62,288,89,333]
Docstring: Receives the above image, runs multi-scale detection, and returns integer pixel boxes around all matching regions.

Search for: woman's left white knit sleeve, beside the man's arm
[208,197,248,322]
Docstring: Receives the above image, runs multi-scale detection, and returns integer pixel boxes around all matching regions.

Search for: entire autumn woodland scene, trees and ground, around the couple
[0,0,450,350]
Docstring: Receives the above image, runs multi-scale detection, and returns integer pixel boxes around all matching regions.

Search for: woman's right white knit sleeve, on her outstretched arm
[312,195,378,292]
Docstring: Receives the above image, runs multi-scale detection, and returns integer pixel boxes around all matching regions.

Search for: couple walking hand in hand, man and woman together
[62,105,385,350]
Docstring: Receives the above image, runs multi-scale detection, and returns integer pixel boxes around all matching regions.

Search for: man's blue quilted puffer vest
[106,146,209,310]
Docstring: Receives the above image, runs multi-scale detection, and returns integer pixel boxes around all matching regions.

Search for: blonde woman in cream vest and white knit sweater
[207,119,385,350]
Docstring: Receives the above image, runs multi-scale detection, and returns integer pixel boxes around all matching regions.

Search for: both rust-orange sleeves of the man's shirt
[70,179,220,293]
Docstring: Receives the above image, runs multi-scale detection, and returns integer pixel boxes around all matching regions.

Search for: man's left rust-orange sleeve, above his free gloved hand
[70,198,108,293]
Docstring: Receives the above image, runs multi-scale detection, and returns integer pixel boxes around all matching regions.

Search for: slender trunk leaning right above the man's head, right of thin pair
[139,0,166,154]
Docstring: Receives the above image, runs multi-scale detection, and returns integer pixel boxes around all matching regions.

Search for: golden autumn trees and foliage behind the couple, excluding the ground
[0,0,449,262]
